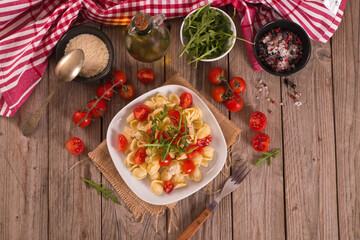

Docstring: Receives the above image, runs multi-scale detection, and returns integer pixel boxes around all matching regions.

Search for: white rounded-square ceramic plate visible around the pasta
[106,85,227,205]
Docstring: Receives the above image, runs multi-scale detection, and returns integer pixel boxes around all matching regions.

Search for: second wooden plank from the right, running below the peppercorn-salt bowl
[282,41,338,239]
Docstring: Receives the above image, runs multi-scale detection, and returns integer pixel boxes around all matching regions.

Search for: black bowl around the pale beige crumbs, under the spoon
[56,25,114,83]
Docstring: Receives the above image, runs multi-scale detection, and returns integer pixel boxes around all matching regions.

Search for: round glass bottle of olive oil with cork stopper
[126,13,170,62]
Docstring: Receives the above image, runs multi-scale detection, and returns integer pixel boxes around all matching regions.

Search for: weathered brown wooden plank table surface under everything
[0,1,360,240]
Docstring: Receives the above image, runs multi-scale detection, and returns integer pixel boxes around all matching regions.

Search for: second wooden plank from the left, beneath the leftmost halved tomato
[49,24,101,239]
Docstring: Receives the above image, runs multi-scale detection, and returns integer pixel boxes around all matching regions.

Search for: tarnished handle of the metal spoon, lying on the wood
[22,80,61,137]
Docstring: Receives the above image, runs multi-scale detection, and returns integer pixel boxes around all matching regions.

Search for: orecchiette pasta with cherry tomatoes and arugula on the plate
[118,93,215,195]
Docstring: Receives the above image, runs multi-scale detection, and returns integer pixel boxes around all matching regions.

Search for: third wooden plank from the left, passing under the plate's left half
[102,27,167,239]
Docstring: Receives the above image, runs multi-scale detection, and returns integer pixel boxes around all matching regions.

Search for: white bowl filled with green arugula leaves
[180,4,237,68]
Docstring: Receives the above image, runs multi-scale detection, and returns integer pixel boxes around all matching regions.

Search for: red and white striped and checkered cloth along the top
[0,0,346,116]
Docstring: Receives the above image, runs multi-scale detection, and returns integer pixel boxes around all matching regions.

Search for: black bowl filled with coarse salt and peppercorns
[254,20,311,76]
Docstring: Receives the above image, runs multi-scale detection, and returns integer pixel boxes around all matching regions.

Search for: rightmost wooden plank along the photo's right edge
[332,1,360,239]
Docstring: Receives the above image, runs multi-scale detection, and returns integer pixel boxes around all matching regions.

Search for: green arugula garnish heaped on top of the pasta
[138,105,196,162]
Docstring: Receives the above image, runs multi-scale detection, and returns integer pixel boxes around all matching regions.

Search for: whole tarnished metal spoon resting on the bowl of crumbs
[22,49,84,137]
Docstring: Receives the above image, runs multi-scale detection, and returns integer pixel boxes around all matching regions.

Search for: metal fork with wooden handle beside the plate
[177,162,251,240]
